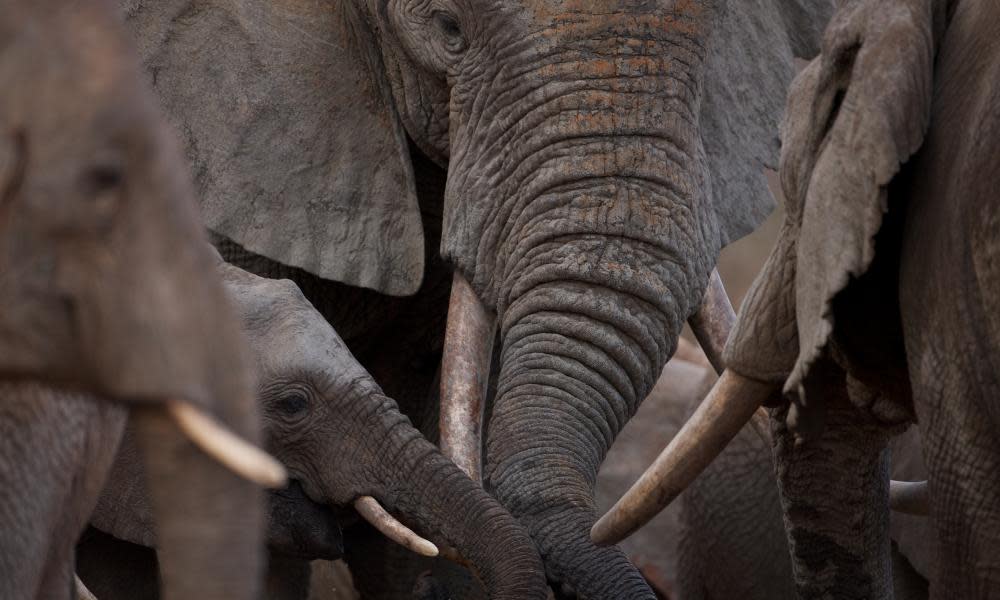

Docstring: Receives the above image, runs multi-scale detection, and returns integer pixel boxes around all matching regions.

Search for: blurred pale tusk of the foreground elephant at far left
[167,401,288,489]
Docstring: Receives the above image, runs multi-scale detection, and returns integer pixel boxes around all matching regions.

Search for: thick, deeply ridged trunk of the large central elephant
[458,27,718,598]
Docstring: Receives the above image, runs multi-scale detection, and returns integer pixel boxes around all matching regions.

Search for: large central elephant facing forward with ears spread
[123,0,830,598]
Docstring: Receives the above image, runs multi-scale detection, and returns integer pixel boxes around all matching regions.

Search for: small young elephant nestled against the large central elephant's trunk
[80,264,545,600]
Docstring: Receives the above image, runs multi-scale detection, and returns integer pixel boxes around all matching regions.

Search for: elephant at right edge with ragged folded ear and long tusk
[597,0,1000,598]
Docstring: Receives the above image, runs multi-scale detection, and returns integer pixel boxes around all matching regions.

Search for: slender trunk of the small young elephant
[365,398,546,600]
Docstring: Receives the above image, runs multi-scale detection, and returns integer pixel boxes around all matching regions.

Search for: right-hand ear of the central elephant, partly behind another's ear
[700,0,833,245]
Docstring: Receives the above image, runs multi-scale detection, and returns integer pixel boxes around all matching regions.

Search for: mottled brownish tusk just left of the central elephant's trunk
[440,272,496,481]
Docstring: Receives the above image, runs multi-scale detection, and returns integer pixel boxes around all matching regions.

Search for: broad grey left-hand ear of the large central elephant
[124,0,424,295]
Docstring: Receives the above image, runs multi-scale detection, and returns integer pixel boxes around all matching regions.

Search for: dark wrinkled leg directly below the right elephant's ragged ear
[772,367,893,600]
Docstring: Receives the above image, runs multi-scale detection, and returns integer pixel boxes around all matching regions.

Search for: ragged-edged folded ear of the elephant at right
[781,0,944,394]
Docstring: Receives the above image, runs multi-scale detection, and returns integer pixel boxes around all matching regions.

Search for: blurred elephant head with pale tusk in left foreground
[0,0,283,598]
